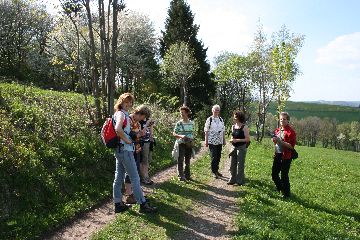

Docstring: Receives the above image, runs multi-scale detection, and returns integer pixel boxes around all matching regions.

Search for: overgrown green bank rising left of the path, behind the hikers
[0,83,178,239]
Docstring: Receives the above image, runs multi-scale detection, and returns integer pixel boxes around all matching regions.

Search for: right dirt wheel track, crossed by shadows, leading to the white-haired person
[174,144,239,240]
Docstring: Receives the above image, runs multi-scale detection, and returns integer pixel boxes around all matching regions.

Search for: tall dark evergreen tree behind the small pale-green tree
[160,0,215,112]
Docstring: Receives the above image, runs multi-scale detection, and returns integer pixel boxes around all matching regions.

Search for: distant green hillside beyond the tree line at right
[270,101,360,122]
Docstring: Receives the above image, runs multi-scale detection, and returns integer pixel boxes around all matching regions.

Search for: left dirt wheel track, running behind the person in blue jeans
[44,145,207,240]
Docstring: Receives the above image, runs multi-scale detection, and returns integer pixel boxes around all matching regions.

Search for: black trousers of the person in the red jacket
[272,153,291,197]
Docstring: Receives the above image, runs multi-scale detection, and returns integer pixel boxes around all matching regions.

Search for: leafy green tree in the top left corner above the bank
[0,0,52,83]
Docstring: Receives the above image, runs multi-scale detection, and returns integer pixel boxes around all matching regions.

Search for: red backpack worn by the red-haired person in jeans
[101,112,127,148]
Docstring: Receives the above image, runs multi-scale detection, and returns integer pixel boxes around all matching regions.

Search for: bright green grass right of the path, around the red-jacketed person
[235,140,360,239]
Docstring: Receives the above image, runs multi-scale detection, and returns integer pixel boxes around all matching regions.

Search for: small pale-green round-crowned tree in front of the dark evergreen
[161,42,199,106]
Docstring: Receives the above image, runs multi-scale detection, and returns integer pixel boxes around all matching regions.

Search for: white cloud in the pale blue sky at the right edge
[316,32,360,69]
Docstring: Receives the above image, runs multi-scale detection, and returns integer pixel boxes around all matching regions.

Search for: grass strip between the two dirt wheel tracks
[92,154,215,239]
